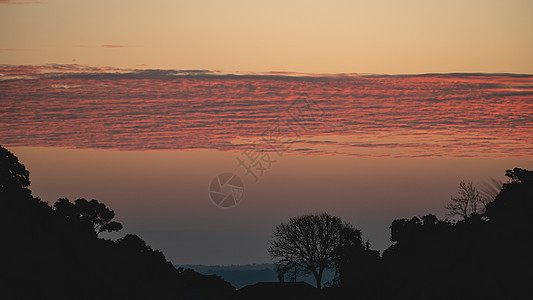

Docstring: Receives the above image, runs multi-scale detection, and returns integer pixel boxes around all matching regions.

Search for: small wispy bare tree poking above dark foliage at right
[444,180,486,220]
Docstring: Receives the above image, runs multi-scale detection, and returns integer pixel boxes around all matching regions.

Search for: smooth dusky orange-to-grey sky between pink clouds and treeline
[12,147,533,264]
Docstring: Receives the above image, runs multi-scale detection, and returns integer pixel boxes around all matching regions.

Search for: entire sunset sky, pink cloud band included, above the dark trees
[0,0,533,264]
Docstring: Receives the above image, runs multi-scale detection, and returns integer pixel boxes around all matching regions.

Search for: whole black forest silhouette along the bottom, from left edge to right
[0,146,533,299]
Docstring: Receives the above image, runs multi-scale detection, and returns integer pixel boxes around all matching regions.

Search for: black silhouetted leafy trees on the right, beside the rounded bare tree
[272,168,533,299]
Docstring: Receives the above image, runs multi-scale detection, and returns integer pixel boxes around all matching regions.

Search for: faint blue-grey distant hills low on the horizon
[175,264,333,289]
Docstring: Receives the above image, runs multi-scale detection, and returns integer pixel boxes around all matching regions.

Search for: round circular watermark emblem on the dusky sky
[208,173,244,208]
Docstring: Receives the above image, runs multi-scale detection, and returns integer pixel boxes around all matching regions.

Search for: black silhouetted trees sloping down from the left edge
[0,146,234,299]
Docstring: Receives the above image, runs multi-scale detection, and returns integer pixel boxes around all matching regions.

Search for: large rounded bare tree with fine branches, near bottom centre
[268,213,346,288]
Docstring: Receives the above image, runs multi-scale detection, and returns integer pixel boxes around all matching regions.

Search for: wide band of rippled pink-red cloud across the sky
[0,64,533,158]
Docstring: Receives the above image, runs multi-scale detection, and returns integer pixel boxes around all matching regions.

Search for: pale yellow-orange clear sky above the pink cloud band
[0,0,533,74]
